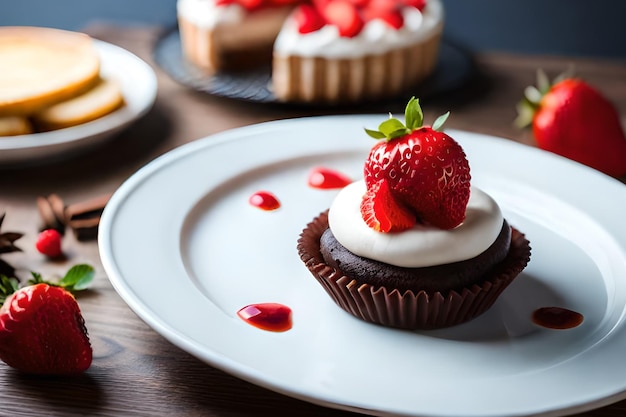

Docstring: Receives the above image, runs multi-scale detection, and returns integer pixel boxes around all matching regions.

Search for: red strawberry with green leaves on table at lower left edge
[0,264,94,375]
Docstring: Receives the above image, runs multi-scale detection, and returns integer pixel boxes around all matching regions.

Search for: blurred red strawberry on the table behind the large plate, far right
[516,71,626,177]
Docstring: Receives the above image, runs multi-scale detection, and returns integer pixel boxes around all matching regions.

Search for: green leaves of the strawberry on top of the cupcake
[365,97,450,142]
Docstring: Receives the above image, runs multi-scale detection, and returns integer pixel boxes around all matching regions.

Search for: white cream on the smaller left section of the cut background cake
[176,0,248,29]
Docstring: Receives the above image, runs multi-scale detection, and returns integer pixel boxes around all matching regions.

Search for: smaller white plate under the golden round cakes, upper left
[0,40,157,166]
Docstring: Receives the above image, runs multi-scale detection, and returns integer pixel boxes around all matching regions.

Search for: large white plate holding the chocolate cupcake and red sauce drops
[99,115,626,417]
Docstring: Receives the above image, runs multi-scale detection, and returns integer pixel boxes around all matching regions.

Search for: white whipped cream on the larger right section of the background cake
[274,0,444,58]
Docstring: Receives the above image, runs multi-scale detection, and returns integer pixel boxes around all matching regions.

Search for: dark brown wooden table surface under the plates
[0,26,626,417]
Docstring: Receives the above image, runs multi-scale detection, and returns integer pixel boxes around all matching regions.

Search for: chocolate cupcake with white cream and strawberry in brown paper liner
[297,98,530,329]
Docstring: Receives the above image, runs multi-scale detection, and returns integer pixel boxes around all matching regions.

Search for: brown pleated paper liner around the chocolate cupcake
[297,211,530,330]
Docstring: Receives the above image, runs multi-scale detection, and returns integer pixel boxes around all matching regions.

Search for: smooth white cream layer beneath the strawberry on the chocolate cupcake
[328,181,504,268]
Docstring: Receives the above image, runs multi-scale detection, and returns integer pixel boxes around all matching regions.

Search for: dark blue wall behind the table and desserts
[0,0,626,59]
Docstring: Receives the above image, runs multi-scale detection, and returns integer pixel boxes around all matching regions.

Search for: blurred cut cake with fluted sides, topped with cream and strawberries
[173,0,444,103]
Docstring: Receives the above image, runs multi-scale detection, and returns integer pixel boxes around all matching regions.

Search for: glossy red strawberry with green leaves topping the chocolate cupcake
[361,98,470,232]
